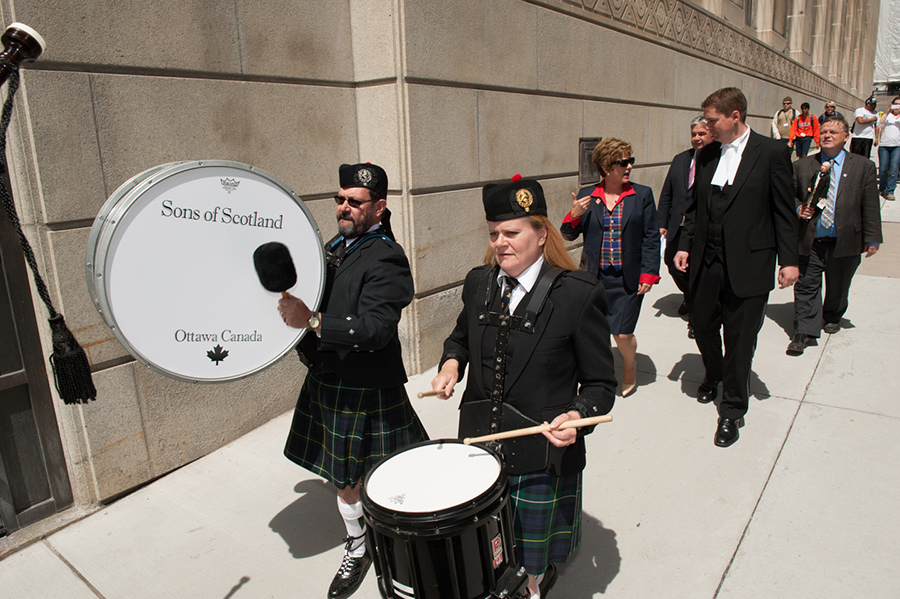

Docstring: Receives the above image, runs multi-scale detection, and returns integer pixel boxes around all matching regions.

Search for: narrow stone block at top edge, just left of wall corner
[348,0,398,82]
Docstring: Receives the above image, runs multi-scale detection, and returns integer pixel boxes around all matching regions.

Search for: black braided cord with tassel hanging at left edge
[0,65,97,404]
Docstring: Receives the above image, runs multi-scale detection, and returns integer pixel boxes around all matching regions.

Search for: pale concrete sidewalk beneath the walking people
[0,202,900,599]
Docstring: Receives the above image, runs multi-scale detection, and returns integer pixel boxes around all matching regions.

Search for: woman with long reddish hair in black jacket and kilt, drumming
[431,175,616,598]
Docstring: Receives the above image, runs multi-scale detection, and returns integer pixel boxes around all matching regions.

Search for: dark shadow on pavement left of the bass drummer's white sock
[269,480,345,559]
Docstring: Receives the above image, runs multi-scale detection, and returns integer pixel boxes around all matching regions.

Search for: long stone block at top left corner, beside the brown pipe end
[15,0,240,73]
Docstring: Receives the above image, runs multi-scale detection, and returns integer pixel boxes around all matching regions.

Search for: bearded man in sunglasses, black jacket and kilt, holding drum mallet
[278,163,427,599]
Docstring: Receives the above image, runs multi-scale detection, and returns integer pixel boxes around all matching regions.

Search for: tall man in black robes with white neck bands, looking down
[675,87,799,447]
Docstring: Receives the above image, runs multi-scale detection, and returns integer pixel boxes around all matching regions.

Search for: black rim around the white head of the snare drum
[360,439,509,534]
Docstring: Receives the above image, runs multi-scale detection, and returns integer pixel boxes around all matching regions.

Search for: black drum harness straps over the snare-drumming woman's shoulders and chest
[478,268,566,433]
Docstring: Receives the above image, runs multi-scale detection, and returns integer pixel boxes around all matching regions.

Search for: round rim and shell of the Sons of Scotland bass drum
[85,160,325,384]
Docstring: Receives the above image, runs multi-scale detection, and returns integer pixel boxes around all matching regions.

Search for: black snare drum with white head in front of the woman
[361,440,527,599]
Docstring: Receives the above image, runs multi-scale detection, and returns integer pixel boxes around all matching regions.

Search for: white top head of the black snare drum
[366,442,501,513]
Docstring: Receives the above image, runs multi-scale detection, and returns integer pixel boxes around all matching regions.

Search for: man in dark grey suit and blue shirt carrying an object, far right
[787,116,882,356]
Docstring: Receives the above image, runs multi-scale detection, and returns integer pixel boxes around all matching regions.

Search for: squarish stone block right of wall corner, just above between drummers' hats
[408,85,479,190]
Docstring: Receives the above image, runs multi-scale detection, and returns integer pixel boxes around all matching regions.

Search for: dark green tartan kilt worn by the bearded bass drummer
[284,372,428,489]
